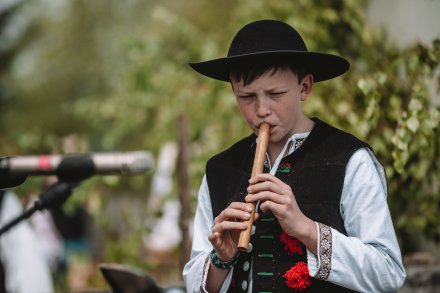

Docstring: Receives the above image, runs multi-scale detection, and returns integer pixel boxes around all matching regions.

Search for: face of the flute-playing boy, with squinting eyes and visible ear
[232,68,313,148]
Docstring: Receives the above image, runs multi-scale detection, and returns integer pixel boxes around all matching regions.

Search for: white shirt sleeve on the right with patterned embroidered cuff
[307,149,406,292]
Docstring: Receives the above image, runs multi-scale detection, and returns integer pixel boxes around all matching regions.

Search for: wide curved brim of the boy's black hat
[189,51,350,82]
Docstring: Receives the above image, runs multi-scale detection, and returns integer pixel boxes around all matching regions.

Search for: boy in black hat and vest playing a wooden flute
[183,20,405,292]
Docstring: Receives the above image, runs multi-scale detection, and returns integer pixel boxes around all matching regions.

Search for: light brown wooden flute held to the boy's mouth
[238,123,270,251]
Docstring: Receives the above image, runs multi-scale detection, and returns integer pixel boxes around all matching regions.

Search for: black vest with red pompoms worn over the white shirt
[206,119,369,292]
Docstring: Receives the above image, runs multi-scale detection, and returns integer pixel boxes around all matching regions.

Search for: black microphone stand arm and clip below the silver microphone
[0,180,81,236]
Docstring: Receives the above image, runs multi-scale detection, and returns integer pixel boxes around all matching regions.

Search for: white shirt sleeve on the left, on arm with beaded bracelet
[183,175,233,293]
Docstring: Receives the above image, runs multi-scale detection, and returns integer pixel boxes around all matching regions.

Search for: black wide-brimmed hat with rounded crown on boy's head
[190,20,350,82]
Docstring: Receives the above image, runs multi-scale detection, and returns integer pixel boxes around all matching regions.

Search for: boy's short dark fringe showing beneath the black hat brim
[230,62,309,86]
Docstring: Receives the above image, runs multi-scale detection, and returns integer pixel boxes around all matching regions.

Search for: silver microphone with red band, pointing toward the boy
[0,151,153,182]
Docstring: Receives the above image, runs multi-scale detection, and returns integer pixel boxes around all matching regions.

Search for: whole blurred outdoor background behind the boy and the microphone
[0,0,440,292]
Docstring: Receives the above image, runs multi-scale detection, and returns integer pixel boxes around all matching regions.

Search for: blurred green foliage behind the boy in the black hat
[0,0,440,286]
